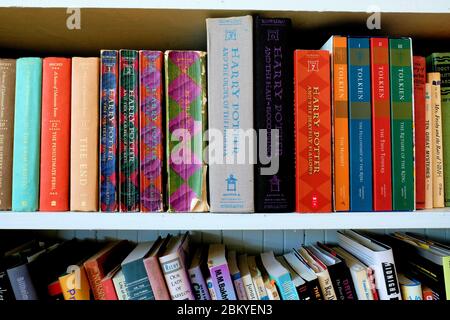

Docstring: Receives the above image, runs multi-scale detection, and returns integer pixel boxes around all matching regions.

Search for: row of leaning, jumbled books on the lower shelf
[0,230,450,300]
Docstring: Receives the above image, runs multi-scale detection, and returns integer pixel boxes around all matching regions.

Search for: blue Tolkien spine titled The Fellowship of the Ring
[348,38,373,211]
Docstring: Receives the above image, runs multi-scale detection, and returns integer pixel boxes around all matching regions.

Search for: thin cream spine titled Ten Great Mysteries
[425,83,434,209]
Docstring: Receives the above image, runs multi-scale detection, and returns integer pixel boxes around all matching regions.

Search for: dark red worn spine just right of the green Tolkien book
[413,56,426,209]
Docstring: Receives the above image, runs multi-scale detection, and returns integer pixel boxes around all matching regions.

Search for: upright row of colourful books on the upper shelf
[0,16,450,212]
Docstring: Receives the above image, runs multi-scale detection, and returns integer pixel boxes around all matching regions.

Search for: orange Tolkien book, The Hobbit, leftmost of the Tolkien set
[322,36,350,211]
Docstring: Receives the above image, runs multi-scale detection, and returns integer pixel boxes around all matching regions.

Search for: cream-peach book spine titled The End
[70,58,100,211]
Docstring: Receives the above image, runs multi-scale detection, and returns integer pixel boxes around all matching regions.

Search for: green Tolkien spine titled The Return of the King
[389,38,415,211]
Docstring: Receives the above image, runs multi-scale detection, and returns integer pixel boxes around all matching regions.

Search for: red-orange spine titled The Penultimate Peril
[39,58,71,211]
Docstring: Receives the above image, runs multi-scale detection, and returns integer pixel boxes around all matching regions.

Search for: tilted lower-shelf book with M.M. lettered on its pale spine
[208,244,237,300]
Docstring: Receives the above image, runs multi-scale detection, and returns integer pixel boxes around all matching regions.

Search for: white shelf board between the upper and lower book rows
[0,210,450,230]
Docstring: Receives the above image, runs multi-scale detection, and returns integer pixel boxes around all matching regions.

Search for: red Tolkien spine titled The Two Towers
[370,38,392,211]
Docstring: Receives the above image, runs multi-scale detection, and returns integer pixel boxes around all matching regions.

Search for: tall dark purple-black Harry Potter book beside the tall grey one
[253,17,295,212]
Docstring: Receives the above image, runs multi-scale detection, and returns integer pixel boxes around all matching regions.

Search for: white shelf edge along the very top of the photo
[0,0,450,13]
